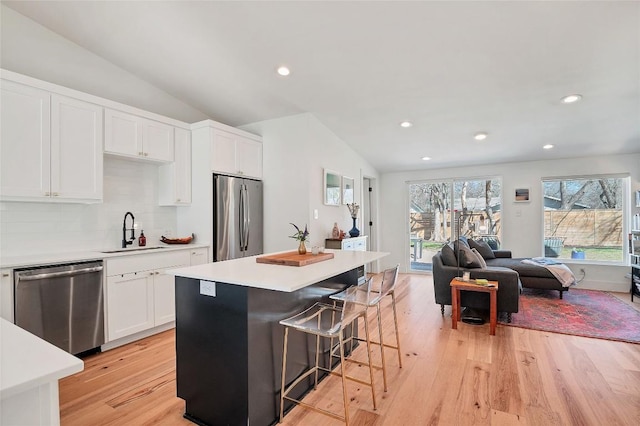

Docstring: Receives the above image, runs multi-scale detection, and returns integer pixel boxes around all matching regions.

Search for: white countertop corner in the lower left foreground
[0,318,84,399]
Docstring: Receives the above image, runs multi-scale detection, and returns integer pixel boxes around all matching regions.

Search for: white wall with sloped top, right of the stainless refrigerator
[242,113,378,252]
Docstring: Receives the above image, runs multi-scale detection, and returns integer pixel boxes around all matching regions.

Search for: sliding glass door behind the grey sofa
[408,178,502,271]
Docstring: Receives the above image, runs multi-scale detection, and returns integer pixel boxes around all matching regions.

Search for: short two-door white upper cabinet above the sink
[104,109,174,162]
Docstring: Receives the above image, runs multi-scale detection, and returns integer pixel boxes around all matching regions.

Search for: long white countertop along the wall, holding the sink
[0,243,209,268]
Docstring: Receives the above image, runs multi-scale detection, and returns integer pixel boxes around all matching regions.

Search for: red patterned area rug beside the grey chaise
[500,288,640,343]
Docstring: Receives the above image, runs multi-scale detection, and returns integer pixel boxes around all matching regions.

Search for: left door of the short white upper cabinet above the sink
[104,109,144,157]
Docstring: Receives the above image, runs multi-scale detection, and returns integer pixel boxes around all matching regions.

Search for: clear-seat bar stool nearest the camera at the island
[280,281,377,426]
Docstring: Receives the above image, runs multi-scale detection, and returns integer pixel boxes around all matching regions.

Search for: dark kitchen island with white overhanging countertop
[169,250,387,426]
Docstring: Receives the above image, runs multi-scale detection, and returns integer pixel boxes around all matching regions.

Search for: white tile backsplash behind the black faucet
[0,156,176,257]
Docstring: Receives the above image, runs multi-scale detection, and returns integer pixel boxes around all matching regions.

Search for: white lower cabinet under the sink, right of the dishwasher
[105,249,192,342]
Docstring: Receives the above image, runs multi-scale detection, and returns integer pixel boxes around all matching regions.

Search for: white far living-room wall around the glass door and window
[380,154,640,291]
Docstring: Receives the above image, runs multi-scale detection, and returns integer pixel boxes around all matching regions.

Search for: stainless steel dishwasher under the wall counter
[14,261,104,355]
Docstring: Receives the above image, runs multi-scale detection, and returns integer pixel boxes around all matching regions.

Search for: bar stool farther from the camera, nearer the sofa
[329,265,402,392]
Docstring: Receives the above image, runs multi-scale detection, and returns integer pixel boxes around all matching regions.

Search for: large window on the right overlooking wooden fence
[542,176,629,262]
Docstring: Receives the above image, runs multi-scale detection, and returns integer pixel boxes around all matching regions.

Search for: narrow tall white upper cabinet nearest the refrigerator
[158,127,191,206]
